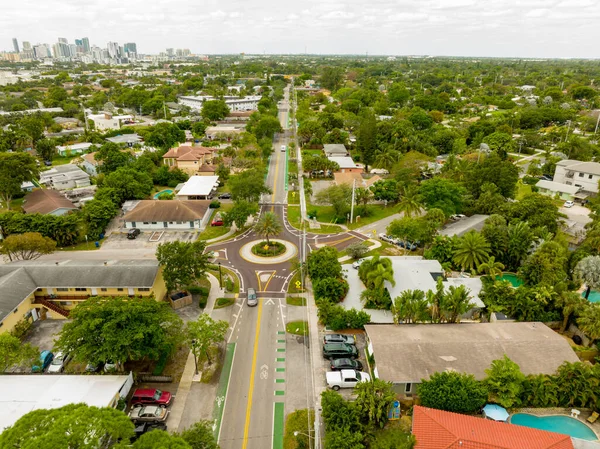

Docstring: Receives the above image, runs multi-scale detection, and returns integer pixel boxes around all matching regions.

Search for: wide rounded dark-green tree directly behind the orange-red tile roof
[417,371,488,413]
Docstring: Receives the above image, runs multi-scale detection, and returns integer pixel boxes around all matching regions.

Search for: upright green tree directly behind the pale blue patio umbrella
[485,354,525,408]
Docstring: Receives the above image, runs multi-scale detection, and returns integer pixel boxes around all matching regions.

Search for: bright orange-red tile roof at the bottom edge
[412,405,573,449]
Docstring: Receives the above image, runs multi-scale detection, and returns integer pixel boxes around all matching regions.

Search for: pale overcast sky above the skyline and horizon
[0,0,600,58]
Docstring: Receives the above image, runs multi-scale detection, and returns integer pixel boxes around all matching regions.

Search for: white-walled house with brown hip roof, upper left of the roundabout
[123,200,212,231]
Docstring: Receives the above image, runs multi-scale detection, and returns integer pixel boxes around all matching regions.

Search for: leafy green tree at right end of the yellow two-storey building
[156,240,209,292]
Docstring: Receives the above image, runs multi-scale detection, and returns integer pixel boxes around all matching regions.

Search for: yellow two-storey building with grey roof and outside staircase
[0,259,166,332]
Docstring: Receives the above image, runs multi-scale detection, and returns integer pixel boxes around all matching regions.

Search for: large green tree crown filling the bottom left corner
[0,404,134,449]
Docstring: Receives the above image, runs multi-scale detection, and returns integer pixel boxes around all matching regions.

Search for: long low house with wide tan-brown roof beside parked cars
[365,320,579,397]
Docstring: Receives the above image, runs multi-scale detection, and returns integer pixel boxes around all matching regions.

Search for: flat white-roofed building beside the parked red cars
[0,373,133,432]
